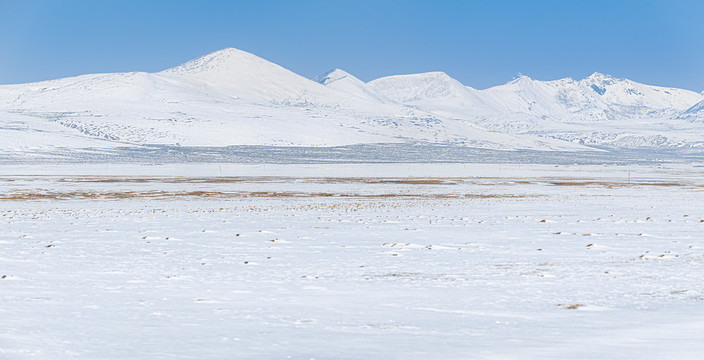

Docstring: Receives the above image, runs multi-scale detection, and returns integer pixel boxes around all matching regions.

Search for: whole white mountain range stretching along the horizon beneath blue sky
[0,48,704,154]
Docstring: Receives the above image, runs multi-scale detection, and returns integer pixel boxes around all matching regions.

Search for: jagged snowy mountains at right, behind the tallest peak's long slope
[369,73,704,147]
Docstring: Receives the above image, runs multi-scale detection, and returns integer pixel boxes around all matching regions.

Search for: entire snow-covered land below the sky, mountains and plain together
[0,48,704,360]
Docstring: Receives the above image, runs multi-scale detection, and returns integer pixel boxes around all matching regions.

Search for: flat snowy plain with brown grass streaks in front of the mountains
[0,164,704,359]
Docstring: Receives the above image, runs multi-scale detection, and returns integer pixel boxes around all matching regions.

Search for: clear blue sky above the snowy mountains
[0,0,704,91]
